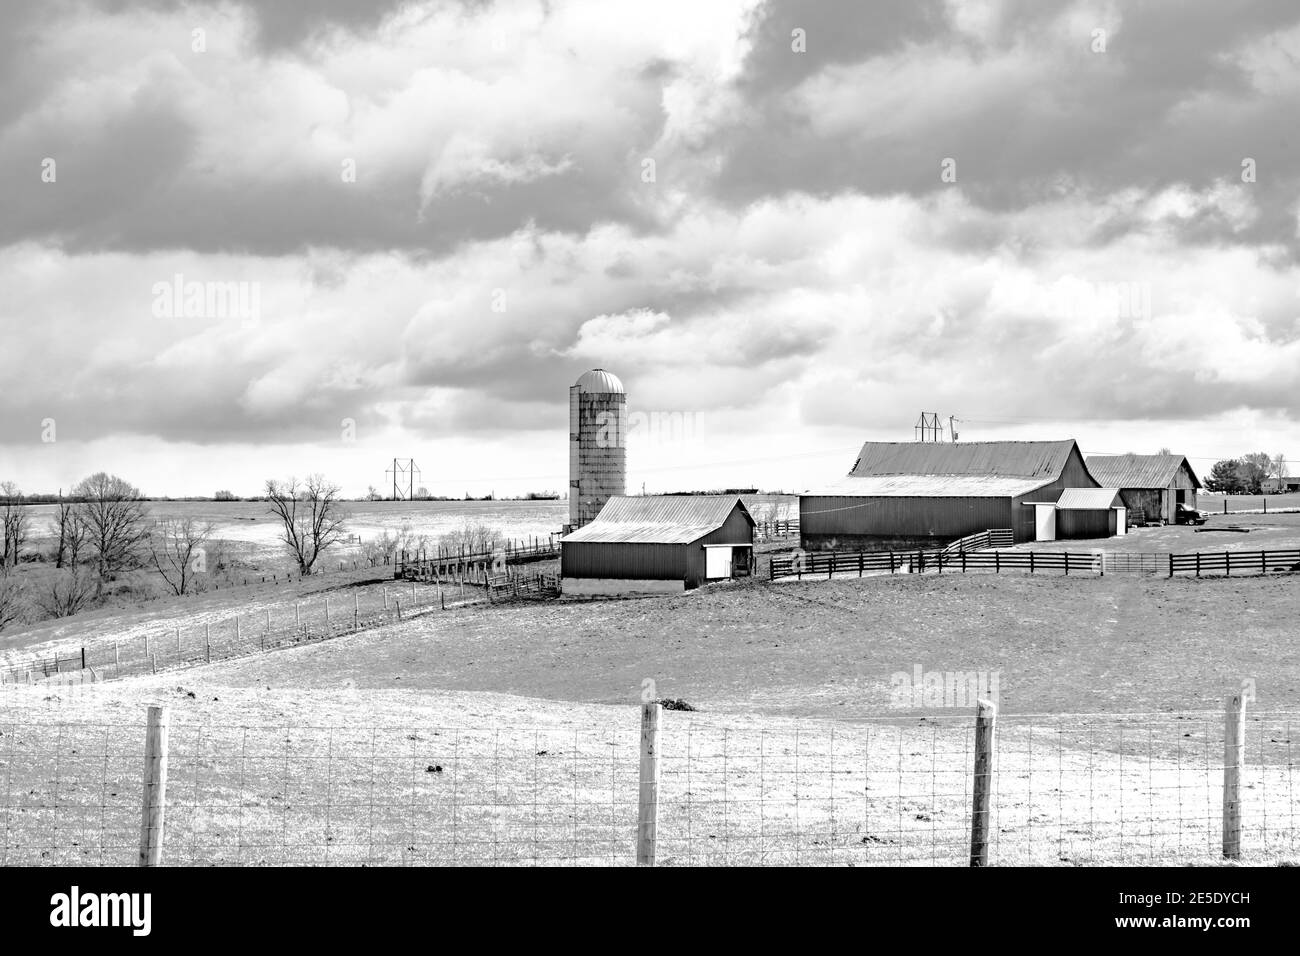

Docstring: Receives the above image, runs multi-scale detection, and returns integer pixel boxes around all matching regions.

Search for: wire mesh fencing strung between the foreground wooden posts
[0,706,1300,866]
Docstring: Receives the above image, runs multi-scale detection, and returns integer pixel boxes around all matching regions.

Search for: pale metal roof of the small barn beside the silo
[560,494,754,545]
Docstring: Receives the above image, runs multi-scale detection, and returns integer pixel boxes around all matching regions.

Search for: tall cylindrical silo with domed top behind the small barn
[569,368,628,529]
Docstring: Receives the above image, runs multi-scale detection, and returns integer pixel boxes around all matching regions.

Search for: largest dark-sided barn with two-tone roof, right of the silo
[800,440,1114,550]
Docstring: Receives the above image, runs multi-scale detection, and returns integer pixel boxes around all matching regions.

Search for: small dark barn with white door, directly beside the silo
[560,494,754,594]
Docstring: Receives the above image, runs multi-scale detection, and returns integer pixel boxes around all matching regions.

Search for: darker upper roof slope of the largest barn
[850,440,1075,485]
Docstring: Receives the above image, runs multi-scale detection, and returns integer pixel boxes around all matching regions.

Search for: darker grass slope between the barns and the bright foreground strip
[131,574,1300,718]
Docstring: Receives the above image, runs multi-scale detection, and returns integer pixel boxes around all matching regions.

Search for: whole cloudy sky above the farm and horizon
[0,0,1300,496]
